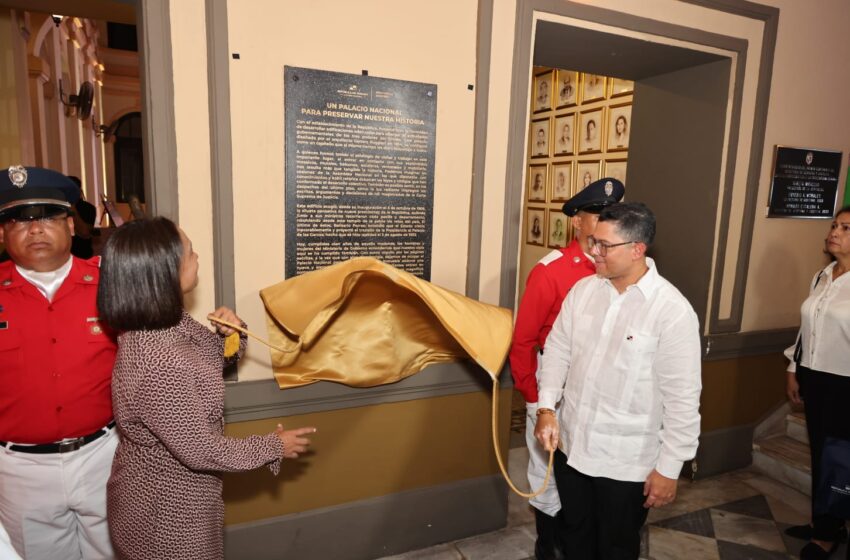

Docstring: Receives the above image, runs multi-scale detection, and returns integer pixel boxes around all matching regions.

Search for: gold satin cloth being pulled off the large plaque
[260,257,512,389]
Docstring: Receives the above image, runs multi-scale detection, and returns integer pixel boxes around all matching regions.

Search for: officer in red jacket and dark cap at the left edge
[0,166,117,560]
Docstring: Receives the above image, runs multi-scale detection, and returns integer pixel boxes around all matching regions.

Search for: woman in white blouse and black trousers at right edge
[785,206,850,560]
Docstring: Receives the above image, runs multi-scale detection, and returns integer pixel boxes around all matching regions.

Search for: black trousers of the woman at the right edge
[797,365,850,542]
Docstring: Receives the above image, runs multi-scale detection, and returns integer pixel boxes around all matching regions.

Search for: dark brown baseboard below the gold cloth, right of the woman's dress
[225,475,508,560]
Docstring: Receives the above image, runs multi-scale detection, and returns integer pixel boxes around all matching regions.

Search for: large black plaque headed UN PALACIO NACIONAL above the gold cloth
[284,66,437,280]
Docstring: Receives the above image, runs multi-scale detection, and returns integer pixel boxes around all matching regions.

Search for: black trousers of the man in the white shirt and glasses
[554,451,648,560]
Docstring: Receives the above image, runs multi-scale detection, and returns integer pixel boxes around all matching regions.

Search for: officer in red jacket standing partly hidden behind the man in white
[510,178,625,560]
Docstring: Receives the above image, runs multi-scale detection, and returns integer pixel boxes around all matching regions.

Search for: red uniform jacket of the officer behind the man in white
[510,240,596,403]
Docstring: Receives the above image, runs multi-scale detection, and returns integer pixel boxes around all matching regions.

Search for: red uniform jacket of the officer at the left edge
[0,257,116,443]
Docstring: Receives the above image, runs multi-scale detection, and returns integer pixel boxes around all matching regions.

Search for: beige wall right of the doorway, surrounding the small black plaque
[743,0,850,330]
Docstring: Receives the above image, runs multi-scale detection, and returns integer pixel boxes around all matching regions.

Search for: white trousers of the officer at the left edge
[0,428,118,560]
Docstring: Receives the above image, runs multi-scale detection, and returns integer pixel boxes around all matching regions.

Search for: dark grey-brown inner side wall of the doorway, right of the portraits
[626,59,731,325]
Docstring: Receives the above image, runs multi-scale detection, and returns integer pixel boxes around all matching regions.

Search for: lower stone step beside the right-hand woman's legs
[753,435,812,496]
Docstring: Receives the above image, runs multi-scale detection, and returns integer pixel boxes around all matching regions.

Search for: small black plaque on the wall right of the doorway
[767,146,841,218]
